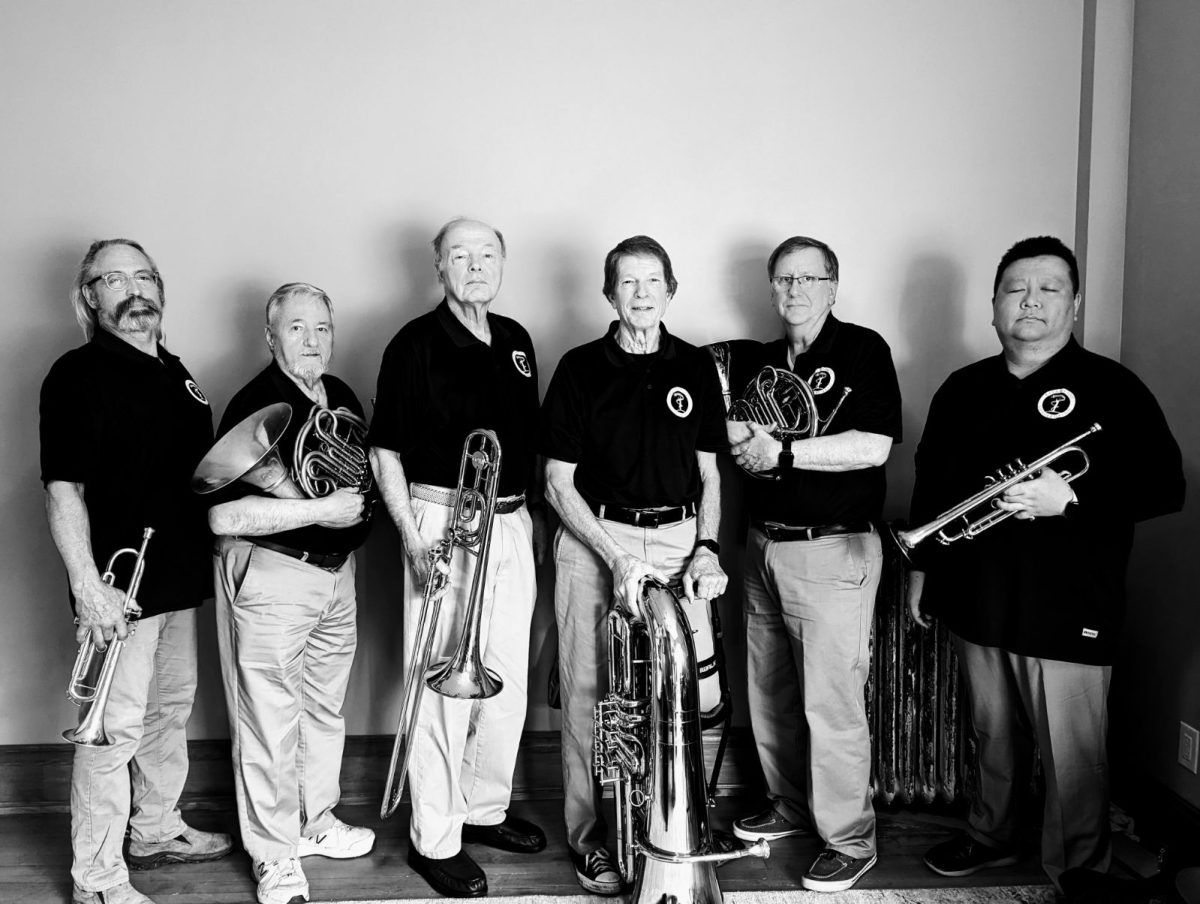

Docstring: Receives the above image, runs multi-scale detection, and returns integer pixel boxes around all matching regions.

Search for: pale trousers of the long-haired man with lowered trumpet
[71,609,196,891]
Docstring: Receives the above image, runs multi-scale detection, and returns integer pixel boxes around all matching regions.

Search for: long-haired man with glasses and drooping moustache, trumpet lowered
[41,239,232,904]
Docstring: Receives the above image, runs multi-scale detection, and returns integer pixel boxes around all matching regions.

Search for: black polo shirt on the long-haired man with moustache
[41,329,212,617]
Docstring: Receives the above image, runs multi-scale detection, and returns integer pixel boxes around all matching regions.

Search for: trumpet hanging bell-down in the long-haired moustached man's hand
[62,527,154,747]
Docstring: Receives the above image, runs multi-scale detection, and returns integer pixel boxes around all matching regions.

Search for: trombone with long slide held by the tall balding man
[379,430,504,819]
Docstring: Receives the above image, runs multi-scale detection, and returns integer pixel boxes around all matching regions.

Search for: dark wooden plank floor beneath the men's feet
[0,797,1046,904]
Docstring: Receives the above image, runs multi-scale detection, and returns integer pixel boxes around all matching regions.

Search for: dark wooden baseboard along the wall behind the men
[0,728,762,815]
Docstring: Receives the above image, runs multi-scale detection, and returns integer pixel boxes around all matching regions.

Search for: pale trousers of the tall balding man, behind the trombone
[404,489,536,860]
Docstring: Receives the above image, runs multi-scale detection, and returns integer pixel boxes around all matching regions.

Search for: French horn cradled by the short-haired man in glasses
[708,342,850,478]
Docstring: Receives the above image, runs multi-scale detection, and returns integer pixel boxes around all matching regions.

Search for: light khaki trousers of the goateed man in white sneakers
[214,537,358,863]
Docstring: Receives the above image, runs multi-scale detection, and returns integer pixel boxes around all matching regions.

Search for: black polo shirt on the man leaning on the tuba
[541,321,728,508]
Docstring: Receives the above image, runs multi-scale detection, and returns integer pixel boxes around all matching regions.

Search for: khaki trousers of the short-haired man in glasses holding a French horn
[743,529,883,857]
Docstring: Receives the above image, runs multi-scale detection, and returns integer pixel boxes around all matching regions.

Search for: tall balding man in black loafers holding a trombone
[370,218,546,897]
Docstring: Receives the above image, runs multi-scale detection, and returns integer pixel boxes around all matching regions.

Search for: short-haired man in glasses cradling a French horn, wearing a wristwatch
[730,235,901,892]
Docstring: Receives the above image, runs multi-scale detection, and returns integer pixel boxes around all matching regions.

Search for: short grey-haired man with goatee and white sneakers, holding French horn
[209,282,374,904]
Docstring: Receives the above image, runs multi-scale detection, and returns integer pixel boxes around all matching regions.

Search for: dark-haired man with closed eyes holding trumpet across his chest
[908,237,1184,884]
